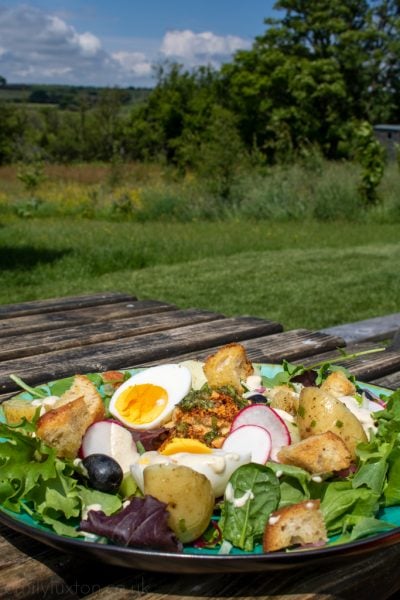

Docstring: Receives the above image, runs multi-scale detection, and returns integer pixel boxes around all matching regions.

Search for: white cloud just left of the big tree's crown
[161,29,250,66]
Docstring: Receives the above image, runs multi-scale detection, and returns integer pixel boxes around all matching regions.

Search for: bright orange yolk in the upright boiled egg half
[115,383,168,425]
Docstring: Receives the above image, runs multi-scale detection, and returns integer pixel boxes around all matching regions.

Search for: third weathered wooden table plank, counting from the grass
[0,308,224,361]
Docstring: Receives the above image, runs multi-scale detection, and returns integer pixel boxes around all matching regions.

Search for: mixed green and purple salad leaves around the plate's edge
[0,361,400,551]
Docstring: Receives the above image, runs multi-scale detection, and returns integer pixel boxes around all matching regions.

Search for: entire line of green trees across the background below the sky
[0,0,400,169]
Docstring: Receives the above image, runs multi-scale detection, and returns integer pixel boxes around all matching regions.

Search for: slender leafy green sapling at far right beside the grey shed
[355,122,385,206]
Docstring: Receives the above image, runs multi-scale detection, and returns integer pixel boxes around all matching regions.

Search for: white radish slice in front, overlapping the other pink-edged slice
[222,425,272,465]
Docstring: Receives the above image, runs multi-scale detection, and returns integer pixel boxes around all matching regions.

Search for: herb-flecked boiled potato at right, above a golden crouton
[297,387,368,460]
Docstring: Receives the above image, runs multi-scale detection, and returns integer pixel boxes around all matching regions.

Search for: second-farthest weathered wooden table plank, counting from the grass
[0,300,176,337]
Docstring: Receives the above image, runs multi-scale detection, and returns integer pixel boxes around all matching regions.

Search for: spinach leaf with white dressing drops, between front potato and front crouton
[219,463,280,552]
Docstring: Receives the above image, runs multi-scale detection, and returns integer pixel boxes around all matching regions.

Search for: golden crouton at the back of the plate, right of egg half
[203,343,254,394]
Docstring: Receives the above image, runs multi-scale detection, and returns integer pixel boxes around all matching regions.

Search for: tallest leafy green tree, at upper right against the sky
[222,0,399,159]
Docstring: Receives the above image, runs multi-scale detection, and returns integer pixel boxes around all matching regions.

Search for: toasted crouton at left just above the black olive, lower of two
[36,398,92,458]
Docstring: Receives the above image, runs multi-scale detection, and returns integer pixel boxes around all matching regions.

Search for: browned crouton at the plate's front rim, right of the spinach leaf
[263,500,328,552]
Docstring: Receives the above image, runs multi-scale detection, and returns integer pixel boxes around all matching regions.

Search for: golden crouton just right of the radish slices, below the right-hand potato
[278,431,351,474]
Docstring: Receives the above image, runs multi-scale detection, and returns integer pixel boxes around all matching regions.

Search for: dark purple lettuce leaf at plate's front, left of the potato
[79,496,182,552]
